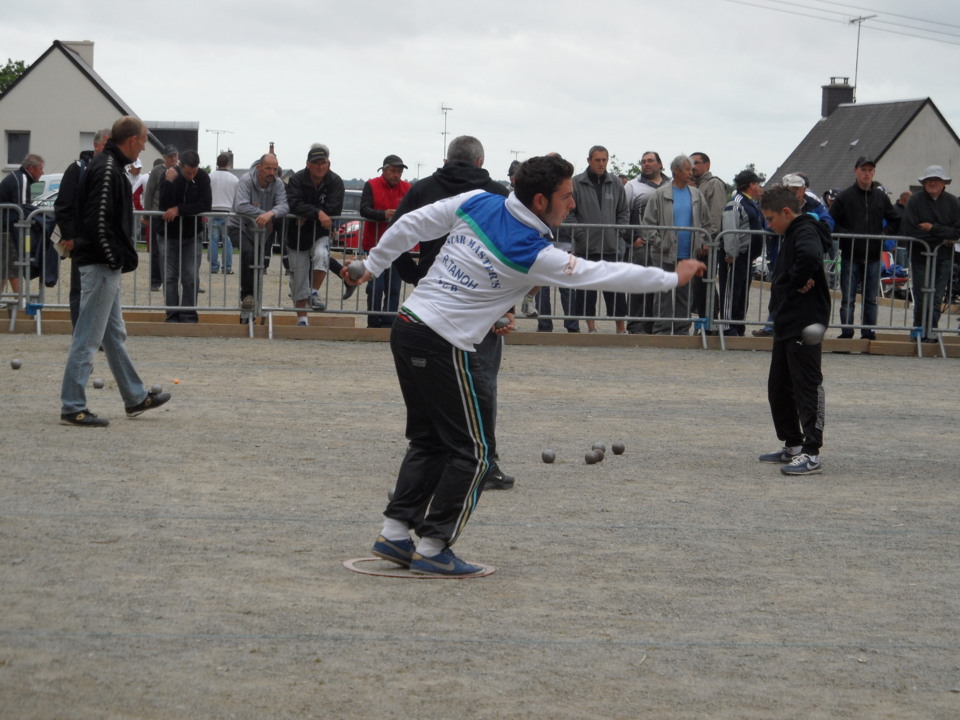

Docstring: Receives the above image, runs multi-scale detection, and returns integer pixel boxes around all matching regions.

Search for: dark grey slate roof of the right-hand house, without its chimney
[767,98,960,194]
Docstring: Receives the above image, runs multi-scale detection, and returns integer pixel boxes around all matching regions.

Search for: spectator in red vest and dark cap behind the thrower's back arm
[360,155,410,328]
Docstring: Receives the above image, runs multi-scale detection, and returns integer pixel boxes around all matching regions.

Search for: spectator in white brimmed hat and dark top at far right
[901,165,960,341]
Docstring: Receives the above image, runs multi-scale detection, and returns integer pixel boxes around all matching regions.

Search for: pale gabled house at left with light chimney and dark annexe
[0,40,199,177]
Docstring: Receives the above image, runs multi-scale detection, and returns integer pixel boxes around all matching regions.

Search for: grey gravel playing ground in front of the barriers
[0,334,960,720]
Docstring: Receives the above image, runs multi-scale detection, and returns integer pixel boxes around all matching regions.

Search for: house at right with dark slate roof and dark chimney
[767,78,960,198]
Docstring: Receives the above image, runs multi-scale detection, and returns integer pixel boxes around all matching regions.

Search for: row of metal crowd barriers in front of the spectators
[0,205,960,355]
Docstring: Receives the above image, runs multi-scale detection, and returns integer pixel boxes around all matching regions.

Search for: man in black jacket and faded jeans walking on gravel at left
[60,116,170,427]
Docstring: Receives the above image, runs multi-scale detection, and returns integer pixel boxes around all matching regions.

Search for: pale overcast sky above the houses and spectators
[7,0,960,186]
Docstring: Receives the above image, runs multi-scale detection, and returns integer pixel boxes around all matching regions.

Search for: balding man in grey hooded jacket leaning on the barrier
[229,153,289,312]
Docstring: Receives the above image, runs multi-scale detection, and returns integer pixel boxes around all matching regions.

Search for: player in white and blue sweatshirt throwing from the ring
[343,157,706,576]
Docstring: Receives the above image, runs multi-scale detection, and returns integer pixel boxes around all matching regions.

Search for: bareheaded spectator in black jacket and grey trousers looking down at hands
[160,150,213,323]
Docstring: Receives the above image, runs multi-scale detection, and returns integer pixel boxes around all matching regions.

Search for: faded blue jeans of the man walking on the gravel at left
[60,265,147,415]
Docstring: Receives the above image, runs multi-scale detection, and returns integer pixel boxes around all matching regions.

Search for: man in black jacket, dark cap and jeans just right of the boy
[830,157,900,340]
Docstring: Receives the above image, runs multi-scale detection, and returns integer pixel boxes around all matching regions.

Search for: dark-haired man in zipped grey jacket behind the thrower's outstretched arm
[567,145,630,335]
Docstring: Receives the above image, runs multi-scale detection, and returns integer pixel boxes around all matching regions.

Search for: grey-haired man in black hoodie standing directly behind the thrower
[382,135,515,490]
